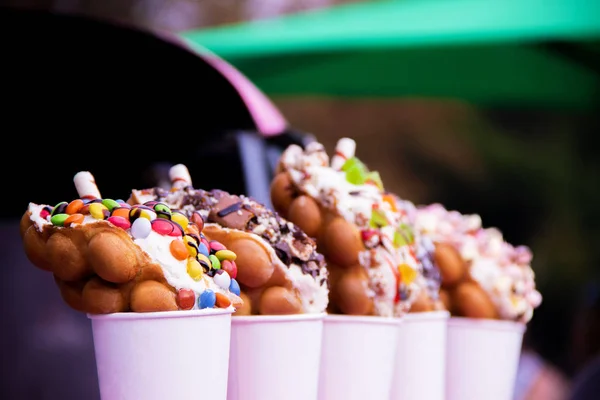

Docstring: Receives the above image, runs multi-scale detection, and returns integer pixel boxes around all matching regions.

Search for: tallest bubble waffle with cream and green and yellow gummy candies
[271,138,434,316]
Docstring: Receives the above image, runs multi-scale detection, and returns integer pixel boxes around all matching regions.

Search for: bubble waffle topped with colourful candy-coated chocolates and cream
[20,172,243,314]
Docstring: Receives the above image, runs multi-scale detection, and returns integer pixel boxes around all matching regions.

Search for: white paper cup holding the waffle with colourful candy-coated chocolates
[88,309,233,400]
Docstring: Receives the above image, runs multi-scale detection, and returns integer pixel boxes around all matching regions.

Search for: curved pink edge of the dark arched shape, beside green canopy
[158,33,288,137]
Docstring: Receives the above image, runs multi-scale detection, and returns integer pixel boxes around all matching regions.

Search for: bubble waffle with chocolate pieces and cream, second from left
[130,164,328,316]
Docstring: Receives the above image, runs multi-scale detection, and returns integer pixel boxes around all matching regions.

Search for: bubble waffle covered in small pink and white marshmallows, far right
[415,204,542,322]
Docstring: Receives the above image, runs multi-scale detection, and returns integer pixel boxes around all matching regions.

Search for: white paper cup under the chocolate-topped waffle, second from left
[227,314,325,400]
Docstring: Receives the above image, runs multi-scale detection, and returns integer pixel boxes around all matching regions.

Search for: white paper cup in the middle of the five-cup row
[319,315,401,400]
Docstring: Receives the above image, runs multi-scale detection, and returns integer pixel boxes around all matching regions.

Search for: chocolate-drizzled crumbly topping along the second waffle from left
[154,187,328,286]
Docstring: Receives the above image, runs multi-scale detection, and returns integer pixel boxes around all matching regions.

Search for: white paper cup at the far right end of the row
[446,317,525,400]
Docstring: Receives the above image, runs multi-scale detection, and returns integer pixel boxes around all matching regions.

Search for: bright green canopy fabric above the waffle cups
[181,0,600,107]
